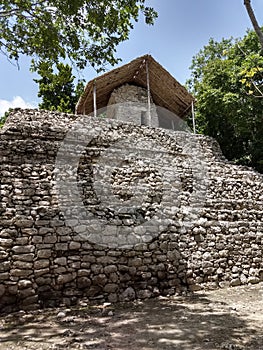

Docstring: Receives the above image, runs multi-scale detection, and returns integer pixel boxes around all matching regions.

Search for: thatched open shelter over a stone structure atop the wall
[76,55,194,129]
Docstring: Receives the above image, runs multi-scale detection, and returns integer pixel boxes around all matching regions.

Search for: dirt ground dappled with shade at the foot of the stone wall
[0,283,263,350]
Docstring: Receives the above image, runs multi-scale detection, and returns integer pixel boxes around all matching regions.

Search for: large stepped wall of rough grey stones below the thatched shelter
[0,110,263,311]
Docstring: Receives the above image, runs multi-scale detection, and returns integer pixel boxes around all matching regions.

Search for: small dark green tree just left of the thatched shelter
[35,63,84,113]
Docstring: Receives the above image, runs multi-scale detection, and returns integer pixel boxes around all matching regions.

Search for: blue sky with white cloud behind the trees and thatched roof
[0,0,263,115]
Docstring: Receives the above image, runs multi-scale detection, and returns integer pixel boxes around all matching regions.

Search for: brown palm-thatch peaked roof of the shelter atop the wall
[76,55,194,118]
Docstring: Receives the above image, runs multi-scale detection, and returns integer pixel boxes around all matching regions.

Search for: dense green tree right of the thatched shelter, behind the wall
[188,32,263,172]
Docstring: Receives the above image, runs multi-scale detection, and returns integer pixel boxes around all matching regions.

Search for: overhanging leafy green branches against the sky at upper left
[0,0,157,69]
